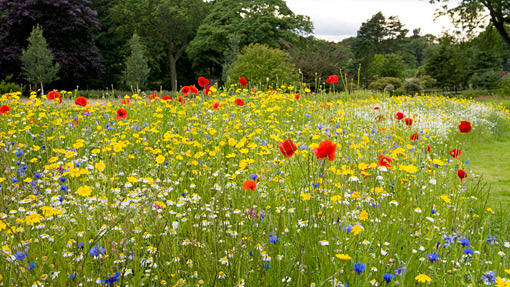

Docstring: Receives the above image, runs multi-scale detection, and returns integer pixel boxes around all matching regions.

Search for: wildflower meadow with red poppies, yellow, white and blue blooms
[0,78,510,287]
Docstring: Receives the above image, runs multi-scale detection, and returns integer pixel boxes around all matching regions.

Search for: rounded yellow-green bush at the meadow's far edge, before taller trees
[228,44,297,88]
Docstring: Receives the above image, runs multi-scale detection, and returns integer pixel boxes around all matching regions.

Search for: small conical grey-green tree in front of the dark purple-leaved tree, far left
[21,26,59,95]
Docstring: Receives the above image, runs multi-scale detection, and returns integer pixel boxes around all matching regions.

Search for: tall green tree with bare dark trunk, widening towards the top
[113,0,210,91]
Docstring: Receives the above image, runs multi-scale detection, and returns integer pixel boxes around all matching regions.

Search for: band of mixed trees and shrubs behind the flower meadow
[0,0,510,93]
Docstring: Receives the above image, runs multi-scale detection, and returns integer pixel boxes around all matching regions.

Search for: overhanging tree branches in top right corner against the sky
[430,0,510,49]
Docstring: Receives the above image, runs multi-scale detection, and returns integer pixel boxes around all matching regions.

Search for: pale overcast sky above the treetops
[287,0,460,41]
